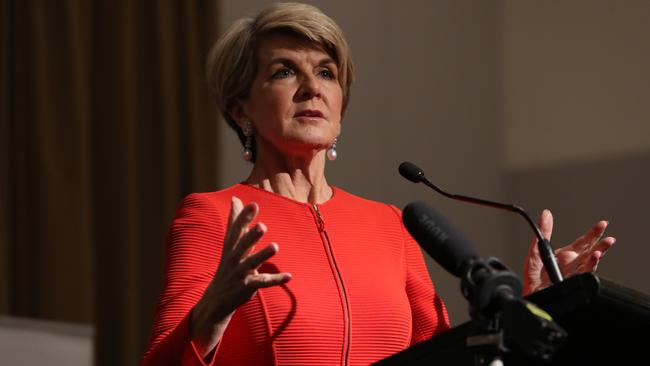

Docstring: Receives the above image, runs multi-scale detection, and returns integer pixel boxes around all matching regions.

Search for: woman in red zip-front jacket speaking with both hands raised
[142,4,614,365]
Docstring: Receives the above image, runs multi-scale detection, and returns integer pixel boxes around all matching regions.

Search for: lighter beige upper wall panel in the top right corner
[502,0,650,168]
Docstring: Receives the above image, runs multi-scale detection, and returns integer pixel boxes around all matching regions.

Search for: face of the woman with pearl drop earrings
[241,34,343,156]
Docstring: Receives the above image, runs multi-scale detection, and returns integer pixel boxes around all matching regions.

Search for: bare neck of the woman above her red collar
[246,150,332,204]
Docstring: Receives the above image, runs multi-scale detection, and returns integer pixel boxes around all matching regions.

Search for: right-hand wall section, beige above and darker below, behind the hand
[501,0,650,293]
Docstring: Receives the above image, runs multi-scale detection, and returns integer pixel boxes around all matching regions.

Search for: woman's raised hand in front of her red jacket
[190,196,291,357]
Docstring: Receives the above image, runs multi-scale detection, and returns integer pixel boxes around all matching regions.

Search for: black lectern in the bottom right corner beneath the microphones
[377,273,650,366]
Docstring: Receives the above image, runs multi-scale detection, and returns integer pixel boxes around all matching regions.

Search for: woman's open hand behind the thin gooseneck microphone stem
[524,210,616,295]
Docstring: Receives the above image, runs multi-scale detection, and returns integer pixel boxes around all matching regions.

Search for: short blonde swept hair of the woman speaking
[206,3,354,154]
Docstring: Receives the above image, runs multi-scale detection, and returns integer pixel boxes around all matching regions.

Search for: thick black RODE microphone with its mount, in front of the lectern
[402,202,567,361]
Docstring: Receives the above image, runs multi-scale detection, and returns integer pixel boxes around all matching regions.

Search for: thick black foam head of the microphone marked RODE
[402,202,479,277]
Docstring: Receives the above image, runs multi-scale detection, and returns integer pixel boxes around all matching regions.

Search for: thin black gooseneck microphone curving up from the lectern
[399,161,562,283]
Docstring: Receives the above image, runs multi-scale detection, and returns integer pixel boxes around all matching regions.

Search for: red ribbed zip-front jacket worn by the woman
[142,184,449,366]
